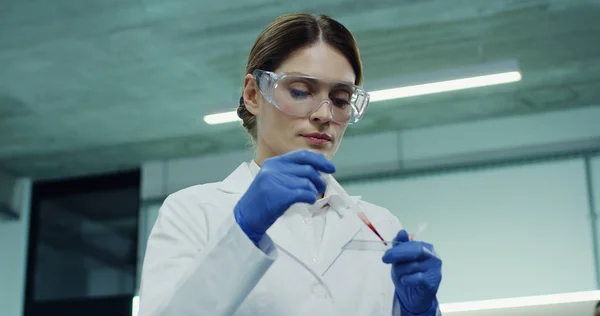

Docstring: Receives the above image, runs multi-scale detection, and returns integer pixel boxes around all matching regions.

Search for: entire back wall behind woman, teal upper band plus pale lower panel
[140,106,600,302]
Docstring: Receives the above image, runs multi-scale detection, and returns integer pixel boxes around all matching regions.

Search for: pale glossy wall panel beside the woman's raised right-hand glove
[344,159,596,302]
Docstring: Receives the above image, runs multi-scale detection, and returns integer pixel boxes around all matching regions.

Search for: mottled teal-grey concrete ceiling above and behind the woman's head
[0,0,600,178]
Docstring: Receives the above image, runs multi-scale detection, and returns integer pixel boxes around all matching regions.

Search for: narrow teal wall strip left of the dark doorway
[0,175,31,316]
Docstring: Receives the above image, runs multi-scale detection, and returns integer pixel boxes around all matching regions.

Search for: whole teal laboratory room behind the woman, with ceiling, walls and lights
[0,0,600,316]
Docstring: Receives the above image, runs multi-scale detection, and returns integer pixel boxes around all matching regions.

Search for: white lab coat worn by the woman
[138,162,401,316]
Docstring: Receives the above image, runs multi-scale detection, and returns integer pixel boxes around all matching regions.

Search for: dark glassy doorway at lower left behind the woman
[25,170,140,316]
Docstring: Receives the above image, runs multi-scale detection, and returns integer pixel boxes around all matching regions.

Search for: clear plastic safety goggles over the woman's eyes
[253,70,369,124]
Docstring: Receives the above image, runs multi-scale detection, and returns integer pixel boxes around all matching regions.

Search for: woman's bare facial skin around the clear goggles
[244,42,355,164]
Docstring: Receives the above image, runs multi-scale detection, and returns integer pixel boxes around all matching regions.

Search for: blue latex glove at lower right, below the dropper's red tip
[382,230,442,316]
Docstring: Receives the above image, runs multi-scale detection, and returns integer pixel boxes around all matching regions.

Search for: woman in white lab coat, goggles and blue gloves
[139,14,441,316]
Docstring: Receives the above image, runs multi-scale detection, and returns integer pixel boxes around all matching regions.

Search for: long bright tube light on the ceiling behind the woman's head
[204,60,521,125]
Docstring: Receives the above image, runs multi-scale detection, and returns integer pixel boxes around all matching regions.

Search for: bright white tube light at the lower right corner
[440,291,600,314]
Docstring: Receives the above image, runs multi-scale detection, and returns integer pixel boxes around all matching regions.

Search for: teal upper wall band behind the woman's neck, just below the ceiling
[141,106,600,195]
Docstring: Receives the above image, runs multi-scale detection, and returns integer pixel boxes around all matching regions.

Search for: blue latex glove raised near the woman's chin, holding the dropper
[233,149,335,246]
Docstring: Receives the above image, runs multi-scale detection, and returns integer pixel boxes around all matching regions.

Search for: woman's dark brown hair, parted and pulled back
[237,13,362,139]
